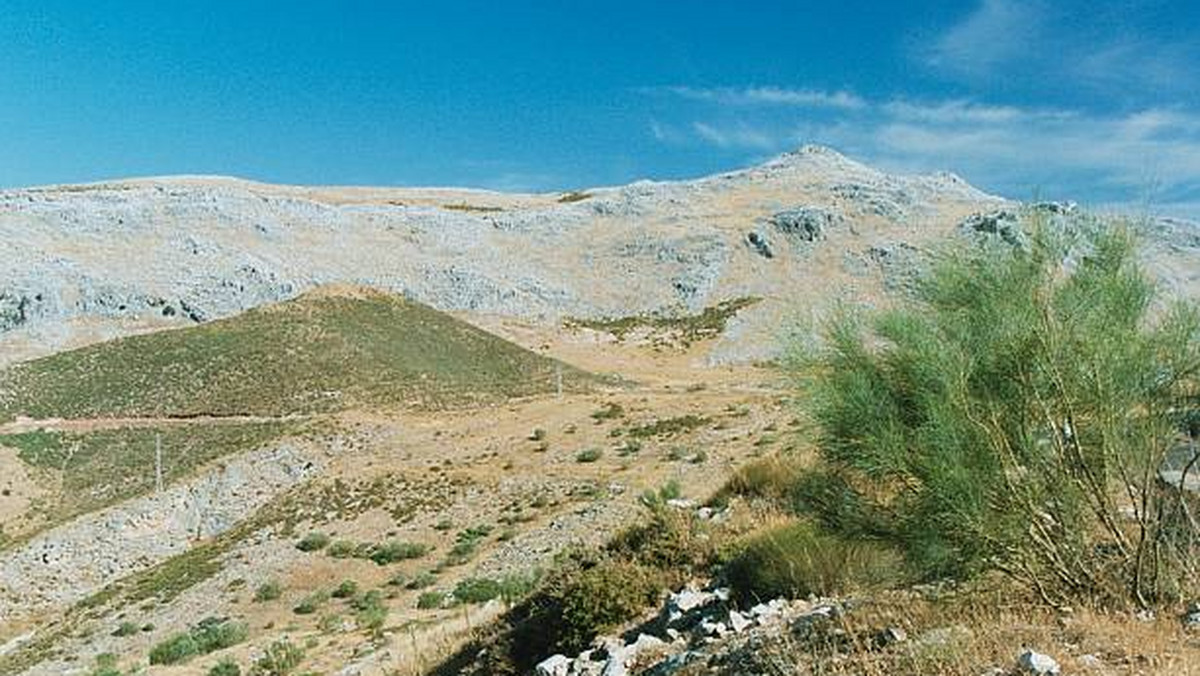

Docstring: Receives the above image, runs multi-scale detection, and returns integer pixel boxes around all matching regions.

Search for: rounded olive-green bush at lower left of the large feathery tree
[724,521,902,603]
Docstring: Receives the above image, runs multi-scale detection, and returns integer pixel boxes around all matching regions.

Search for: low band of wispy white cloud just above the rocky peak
[659,85,1200,217]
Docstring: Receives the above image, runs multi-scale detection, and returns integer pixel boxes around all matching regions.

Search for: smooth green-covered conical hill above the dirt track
[0,291,595,420]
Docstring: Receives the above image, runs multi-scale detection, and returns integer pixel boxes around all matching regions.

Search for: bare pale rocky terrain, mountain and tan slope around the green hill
[0,148,1200,675]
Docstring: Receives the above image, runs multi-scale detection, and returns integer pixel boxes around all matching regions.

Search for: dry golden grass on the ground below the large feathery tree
[700,582,1200,676]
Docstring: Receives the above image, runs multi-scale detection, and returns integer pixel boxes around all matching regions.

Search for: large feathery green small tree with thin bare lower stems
[802,221,1200,606]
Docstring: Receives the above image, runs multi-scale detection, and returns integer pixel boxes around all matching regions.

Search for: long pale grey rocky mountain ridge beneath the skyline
[0,146,1003,360]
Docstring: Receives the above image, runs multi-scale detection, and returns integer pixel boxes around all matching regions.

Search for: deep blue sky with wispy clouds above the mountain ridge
[0,0,1200,216]
